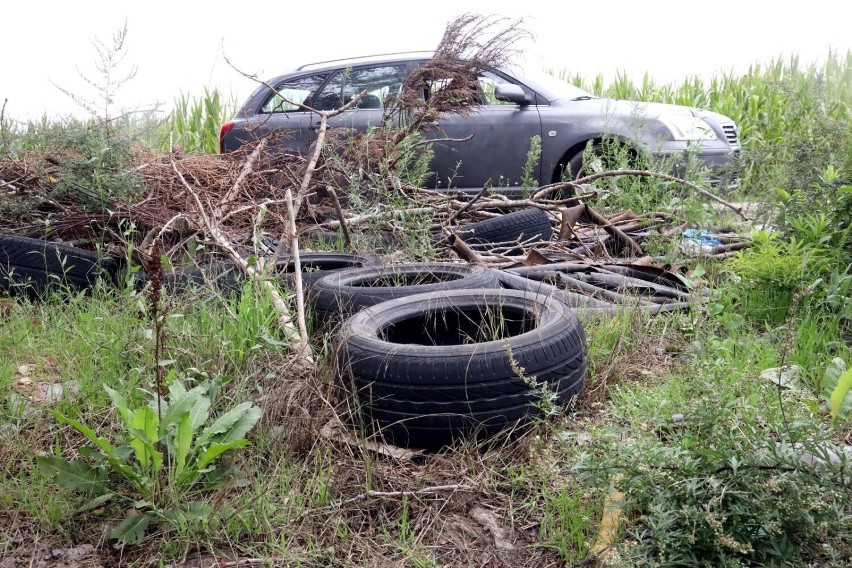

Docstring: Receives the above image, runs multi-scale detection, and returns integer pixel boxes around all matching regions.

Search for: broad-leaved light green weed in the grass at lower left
[36,378,261,545]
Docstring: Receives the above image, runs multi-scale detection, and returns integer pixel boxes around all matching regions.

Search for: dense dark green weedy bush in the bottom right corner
[577,407,852,566]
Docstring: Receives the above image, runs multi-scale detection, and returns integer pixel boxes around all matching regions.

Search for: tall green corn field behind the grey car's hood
[554,51,852,197]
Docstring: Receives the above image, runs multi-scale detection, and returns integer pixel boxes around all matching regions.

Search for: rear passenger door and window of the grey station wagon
[308,62,408,141]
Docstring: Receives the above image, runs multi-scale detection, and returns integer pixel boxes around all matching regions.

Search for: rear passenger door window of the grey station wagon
[313,64,406,110]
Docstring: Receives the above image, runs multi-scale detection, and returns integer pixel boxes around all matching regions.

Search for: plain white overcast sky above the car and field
[0,0,852,119]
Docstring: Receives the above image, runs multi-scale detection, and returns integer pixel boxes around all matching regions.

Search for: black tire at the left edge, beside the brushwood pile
[0,235,119,299]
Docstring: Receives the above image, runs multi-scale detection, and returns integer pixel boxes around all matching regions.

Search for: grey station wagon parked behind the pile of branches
[220,52,740,191]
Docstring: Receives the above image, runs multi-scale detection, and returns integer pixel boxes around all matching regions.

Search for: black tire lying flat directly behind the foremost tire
[308,262,500,325]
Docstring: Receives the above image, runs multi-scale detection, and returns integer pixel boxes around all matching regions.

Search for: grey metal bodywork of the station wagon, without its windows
[222,52,740,190]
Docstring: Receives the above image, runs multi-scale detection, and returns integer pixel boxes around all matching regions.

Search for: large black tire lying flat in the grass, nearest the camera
[338,290,587,448]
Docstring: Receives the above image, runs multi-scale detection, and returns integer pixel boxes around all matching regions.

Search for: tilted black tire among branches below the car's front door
[455,207,553,248]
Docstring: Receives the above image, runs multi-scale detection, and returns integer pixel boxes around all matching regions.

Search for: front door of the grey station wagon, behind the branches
[427,72,542,189]
